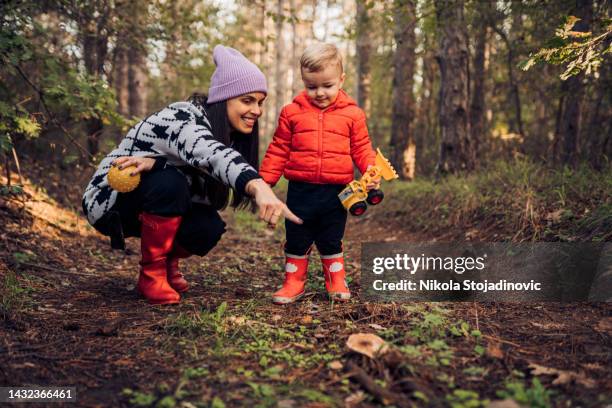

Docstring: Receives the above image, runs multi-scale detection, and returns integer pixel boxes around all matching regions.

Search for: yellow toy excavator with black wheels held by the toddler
[338,149,399,216]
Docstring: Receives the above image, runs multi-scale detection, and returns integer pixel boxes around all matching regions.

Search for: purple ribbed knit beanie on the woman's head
[208,45,268,103]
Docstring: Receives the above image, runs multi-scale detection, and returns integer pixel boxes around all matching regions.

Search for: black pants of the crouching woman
[94,166,225,256]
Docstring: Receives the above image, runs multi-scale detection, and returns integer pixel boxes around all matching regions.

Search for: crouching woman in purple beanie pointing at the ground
[83,45,301,304]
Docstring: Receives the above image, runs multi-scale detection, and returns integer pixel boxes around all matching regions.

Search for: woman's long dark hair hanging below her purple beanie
[188,93,259,210]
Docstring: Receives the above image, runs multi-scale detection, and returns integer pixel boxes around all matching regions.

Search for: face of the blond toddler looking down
[302,64,345,109]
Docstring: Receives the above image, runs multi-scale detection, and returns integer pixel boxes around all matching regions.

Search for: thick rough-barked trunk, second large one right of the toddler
[435,0,475,174]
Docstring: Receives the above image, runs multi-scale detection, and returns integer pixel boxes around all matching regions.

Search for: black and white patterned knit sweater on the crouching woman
[83,102,259,225]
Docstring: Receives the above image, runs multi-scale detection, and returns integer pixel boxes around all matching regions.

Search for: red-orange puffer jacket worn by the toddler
[259,90,376,185]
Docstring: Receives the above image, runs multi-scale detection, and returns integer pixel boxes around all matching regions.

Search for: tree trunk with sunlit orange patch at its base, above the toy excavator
[390,0,416,180]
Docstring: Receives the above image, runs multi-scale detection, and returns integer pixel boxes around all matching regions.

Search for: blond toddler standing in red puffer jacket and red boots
[259,44,380,304]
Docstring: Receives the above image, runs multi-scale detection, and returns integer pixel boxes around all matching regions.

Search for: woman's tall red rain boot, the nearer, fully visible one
[137,213,181,305]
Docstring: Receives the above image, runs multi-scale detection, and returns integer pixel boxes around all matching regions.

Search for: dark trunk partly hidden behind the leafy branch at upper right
[560,0,593,166]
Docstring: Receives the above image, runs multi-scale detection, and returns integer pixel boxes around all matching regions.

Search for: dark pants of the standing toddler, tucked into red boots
[285,181,346,256]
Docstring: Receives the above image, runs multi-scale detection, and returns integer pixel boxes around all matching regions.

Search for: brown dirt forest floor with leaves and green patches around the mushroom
[0,164,612,408]
